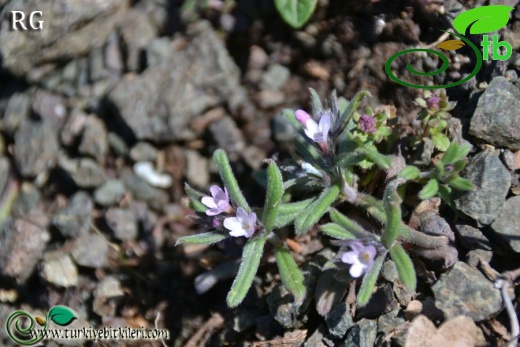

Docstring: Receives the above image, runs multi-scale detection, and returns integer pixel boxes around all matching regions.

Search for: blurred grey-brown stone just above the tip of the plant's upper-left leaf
[209,116,246,160]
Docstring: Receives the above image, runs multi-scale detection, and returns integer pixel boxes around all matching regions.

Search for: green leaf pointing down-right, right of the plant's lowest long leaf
[274,246,306,303]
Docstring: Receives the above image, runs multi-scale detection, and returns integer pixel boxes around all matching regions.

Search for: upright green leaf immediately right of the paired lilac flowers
[262,160,283,232]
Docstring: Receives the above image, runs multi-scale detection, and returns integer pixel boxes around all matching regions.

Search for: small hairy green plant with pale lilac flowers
[177,89,471,314]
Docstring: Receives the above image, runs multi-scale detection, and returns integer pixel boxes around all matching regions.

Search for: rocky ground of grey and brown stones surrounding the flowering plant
[0,0,520,346]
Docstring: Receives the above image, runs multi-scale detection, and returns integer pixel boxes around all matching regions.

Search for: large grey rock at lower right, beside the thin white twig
[432,262,502,322]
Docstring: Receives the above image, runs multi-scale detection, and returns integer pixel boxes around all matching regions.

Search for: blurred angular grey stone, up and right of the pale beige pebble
[52,191,94,238]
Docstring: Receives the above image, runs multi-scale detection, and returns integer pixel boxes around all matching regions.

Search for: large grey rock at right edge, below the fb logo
[469,77,520,149]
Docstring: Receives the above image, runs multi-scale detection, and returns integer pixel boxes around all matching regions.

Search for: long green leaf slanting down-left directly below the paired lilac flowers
[226,235,267,308]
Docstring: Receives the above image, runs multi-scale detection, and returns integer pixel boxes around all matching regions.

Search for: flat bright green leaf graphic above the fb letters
[453,5,514,35]
